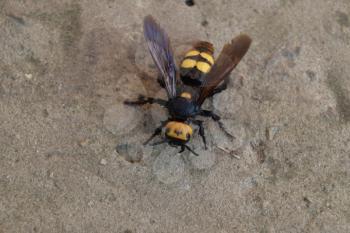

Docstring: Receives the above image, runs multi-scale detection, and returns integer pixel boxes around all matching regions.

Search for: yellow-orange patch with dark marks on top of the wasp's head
[165,121,193,141]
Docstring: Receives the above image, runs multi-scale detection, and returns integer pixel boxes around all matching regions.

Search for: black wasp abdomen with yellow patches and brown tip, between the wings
[180,41,214,86]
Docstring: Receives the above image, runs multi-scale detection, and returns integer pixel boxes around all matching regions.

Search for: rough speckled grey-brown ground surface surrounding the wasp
[0,0,350,233]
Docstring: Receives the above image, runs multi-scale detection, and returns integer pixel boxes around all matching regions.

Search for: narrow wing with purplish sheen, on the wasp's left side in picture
[143,15,176,98]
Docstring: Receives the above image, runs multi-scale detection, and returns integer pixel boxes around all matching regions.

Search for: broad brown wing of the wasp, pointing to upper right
[197,34,252,105]
